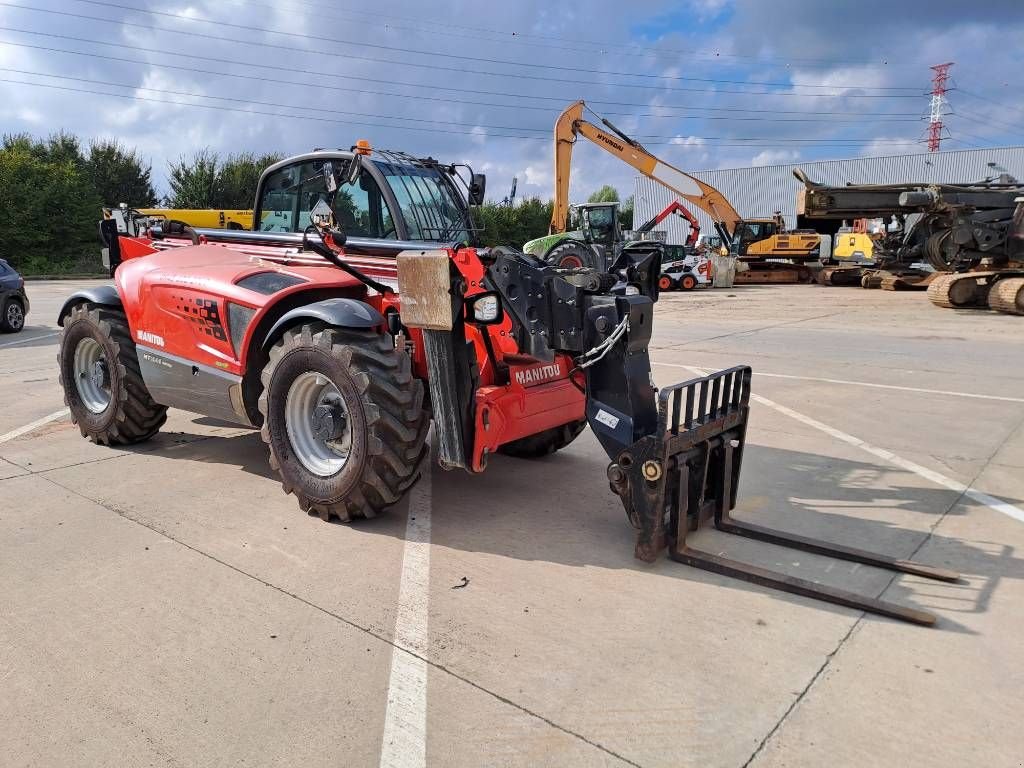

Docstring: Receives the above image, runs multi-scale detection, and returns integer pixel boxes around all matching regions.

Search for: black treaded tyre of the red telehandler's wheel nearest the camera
[259,324,430,522]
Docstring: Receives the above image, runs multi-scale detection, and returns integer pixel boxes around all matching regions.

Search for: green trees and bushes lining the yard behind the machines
[0,132,633,274]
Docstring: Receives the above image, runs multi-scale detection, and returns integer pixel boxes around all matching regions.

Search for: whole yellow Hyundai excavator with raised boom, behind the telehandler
[525,101,821,282]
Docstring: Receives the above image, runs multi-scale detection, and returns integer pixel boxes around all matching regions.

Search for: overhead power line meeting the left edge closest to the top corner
[0,0,921,99]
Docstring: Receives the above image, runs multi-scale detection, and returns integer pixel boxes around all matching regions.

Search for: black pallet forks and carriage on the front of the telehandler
[608,366,959,625]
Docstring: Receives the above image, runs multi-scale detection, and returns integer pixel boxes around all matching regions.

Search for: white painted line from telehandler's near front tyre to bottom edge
[380,457,433,768]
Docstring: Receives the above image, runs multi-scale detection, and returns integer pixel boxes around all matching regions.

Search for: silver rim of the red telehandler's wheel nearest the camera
[285,371,352,477]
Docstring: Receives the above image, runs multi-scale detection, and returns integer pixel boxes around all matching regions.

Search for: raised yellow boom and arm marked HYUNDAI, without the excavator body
[549,101,741,242]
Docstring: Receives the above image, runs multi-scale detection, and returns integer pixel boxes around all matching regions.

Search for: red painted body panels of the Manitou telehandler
[115,231,586,472]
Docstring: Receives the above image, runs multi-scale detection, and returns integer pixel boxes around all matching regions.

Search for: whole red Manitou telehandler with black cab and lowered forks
[59,142,956,624]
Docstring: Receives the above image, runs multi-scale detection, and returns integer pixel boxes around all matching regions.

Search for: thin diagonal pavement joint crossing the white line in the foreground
[38,474,643,768]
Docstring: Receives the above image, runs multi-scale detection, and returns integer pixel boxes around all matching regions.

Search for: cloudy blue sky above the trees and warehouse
[0,0,1024,204]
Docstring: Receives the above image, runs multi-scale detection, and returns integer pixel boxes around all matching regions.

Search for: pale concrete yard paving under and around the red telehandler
[0,281,1024,768]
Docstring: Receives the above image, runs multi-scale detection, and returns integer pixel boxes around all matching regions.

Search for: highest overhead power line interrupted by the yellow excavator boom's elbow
[0,39,921,124]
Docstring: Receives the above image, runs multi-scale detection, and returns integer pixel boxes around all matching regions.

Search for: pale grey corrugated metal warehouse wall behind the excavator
[634,146,1024,244]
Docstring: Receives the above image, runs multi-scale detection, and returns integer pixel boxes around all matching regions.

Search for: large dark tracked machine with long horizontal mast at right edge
[795,170,1024,314]
